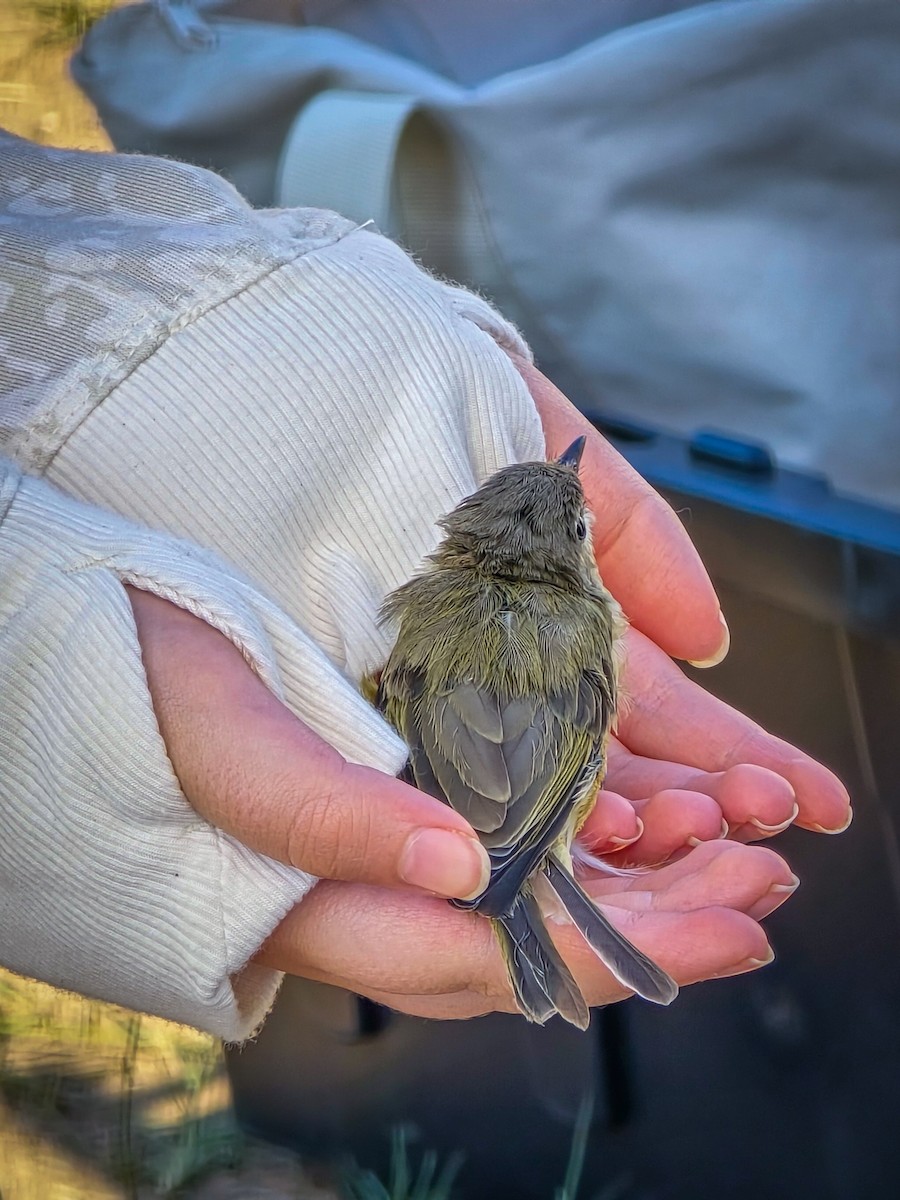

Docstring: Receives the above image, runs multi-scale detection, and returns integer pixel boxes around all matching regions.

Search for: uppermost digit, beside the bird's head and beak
[516,360,727,664]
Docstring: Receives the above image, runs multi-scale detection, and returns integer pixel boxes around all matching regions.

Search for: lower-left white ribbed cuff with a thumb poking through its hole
[0,458,404,1040]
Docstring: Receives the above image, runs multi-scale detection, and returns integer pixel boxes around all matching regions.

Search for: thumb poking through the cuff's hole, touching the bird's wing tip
[130,589,490,896]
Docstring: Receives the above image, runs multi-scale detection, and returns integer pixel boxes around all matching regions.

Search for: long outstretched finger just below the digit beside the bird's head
[616,630,852,833]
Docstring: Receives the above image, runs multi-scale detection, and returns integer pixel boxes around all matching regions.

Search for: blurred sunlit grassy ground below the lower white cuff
[0,971,335,1200]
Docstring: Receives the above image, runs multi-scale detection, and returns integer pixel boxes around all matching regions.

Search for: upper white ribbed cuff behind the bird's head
[46,230,544,683]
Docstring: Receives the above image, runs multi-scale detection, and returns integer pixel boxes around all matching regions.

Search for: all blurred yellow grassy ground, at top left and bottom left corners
[0,0,335,1200]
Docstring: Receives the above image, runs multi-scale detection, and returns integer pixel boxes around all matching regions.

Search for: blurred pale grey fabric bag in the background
[73,0,900,509]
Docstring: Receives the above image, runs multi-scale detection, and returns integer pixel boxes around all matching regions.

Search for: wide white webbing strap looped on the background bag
[275,90,418,236]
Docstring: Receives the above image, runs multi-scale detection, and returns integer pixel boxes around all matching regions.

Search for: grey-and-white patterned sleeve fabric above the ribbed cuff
[0,131,353,469]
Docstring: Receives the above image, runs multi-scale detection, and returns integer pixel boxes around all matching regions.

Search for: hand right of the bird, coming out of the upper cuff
[514,359,851,865]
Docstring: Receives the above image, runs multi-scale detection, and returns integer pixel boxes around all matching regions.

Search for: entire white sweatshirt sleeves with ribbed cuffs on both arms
[0,129,544,1039]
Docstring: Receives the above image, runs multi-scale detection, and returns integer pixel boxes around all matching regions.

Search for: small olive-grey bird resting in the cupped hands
[368,437,678,1030]
